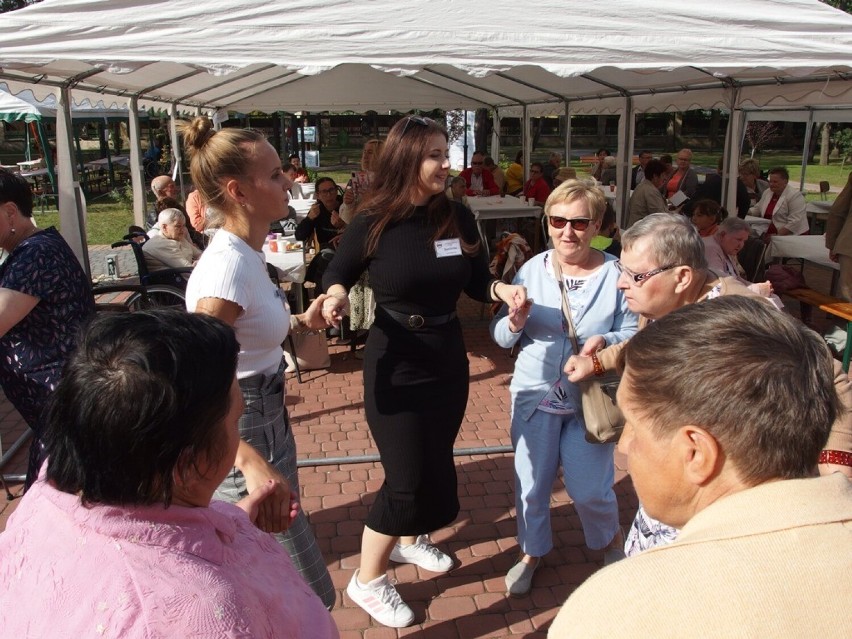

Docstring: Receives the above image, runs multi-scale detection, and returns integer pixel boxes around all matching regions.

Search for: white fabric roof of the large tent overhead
[0,0,852,115]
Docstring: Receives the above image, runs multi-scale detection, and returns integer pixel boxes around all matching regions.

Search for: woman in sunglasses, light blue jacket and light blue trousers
[491,180,638,596]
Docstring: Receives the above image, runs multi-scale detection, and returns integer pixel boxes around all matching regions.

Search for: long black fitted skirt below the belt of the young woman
[364,311,470,536]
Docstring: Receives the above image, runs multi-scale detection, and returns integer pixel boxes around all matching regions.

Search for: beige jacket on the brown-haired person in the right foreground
[547,474,852,639]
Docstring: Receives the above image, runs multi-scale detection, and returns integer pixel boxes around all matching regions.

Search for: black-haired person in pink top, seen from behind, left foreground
[0,310,338,638]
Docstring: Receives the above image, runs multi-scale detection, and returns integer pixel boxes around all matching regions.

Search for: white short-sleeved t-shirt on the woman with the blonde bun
[186,229,290,379]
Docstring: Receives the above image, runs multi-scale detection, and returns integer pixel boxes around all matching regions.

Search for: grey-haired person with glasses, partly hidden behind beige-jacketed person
[565,213,852,556]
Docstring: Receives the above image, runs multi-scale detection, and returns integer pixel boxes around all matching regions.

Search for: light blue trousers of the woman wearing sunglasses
[512,410,618,557]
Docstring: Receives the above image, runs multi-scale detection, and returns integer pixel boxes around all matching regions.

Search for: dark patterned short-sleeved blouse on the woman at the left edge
[0,227,95,433]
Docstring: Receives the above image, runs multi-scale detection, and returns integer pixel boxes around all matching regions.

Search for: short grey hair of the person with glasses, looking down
[621,213,707,271]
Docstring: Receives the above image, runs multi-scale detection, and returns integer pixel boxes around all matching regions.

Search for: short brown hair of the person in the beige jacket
[622,295,842,485]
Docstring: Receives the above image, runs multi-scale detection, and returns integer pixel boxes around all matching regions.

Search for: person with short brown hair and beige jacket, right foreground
[548,298,852,639]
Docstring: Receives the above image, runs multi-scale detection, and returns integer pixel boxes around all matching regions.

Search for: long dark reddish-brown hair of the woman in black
[358,116,479,255]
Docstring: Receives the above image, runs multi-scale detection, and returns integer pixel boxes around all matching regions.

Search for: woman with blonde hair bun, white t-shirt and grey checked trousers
[183,117,335,608]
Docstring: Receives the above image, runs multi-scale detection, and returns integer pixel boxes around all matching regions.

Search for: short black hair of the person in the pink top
[44,309,239,506]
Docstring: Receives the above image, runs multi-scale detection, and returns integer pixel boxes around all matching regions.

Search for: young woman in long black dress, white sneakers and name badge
[323,116,526,627]
